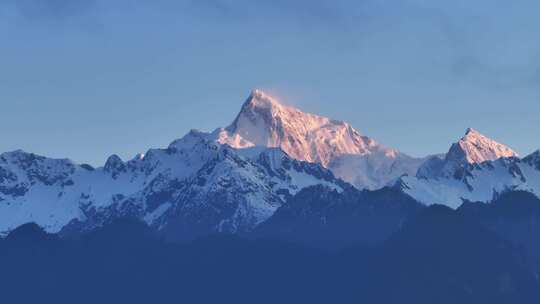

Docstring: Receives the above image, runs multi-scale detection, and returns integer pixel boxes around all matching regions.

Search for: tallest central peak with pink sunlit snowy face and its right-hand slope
[214,90,423,189]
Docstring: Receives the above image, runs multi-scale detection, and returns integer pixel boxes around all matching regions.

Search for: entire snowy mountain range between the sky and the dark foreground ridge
[0,90,540,240]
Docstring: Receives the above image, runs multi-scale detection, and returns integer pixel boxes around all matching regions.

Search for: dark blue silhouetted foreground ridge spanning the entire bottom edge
[0,207,540,304]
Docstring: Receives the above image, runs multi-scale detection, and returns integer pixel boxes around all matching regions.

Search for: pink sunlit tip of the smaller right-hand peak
[448,128,518,164]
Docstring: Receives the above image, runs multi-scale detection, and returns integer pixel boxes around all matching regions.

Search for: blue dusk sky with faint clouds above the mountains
[0,0,540,165]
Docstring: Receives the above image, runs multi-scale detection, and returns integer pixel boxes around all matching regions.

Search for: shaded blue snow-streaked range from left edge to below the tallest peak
[0,131,343,238]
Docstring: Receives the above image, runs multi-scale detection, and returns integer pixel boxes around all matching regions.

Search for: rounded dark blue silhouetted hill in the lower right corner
[348,205,540,304]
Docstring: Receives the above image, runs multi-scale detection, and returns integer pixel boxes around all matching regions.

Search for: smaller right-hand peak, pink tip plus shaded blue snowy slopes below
[401,129,540,208]
